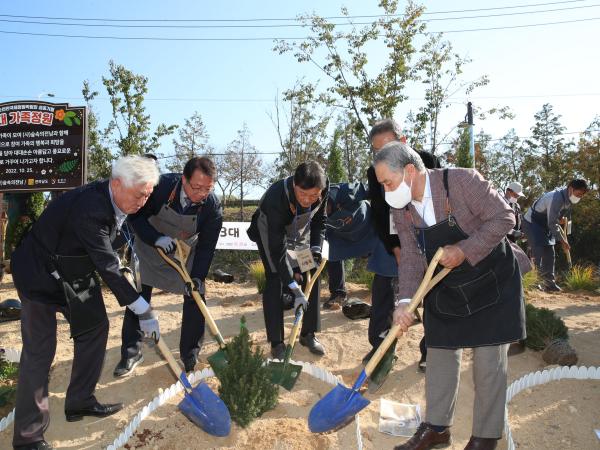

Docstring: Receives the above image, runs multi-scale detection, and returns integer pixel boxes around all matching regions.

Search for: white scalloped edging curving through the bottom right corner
[504,366,600,450]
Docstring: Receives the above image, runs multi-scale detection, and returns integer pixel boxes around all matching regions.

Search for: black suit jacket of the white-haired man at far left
[11,180,139,306]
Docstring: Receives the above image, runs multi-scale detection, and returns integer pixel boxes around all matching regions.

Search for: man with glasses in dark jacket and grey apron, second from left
[114,157,223,377]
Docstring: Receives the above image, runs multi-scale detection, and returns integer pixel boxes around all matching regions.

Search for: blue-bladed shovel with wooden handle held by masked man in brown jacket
[308,248,450,433]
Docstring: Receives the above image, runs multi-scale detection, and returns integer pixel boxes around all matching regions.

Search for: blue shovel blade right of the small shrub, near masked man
[308,384,371,433]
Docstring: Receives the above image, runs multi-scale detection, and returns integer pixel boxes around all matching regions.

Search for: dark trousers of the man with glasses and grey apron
[121,284,204,360]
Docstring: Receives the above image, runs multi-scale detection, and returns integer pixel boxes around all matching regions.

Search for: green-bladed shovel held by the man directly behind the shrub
[268,257,327,391]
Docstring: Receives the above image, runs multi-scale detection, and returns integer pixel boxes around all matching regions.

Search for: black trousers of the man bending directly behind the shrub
[258,243,321,344]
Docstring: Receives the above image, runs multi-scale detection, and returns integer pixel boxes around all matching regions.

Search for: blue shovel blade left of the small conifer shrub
[179,379,231,437]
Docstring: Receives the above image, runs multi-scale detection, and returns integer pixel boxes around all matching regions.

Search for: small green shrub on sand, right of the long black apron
[525,303,569,351]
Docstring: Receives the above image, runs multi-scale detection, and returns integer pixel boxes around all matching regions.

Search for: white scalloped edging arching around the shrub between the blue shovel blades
[106,361,363,450]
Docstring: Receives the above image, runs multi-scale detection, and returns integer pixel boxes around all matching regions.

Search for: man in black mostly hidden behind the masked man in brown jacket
[363,119,441,370]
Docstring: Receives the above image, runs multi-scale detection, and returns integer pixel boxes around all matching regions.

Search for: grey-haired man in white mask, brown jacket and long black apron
[375,142,525,450]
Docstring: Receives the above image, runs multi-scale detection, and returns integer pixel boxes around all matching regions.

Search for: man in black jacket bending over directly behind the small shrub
[248,161,329,359]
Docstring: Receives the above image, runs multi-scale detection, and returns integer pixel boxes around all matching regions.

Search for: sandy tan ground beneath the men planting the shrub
[0,276,600,450]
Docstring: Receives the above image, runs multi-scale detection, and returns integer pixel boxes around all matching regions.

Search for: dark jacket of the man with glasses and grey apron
[127,173,223,280]
